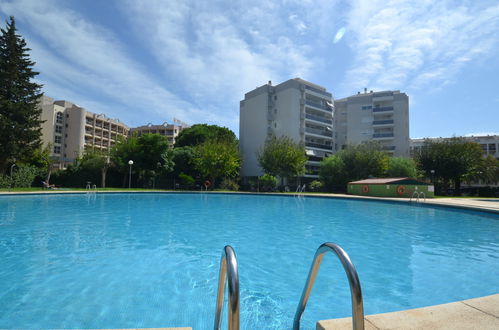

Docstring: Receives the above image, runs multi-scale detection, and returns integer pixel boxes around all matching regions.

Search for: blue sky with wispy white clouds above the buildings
[0,0,499,138]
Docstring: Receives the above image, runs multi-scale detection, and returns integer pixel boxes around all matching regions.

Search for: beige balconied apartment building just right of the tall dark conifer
[40,96,129,168]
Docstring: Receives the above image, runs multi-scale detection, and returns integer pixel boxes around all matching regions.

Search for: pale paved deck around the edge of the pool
[0,190,499,330]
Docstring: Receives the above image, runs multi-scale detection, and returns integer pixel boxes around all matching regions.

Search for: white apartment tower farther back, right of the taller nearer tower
[334,89,409,157]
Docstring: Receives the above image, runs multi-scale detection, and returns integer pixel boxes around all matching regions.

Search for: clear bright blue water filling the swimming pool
[0,194,499,329]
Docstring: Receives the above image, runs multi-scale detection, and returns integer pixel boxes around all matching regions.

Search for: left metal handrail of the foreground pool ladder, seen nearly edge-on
[214,245,239,330]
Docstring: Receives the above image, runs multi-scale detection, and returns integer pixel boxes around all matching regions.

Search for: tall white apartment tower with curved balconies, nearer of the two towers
[239,78,334,178]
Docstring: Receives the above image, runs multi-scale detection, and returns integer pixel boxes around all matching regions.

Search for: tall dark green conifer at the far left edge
[0,16,43,173]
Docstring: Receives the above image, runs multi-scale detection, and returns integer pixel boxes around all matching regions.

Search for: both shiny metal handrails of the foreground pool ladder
[214,243,364,330]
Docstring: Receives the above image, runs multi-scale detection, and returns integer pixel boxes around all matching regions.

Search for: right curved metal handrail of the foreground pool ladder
[293,243,364,330]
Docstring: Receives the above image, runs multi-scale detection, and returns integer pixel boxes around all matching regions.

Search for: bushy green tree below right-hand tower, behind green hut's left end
[319,141,390,191]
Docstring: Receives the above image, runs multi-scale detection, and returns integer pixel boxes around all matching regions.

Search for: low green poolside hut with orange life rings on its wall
[347,178,435,198]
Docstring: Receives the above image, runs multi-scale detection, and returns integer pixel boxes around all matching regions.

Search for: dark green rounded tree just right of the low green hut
[416,137,482,195]
